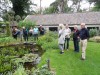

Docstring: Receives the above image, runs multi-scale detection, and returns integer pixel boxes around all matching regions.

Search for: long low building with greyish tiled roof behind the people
[25,12,100,29]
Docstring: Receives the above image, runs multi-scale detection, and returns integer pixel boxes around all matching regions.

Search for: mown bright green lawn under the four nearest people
[39,42,100,75]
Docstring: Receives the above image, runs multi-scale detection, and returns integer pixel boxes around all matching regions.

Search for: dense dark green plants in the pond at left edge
[0,47,29,75]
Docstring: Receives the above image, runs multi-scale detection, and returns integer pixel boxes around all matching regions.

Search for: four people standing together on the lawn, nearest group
[58,23,89,60]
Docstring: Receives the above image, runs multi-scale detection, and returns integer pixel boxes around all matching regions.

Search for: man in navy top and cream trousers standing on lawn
[79,23,89,60]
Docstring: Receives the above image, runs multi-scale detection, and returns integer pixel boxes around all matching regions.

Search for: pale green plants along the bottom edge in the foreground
[7,65,56,75]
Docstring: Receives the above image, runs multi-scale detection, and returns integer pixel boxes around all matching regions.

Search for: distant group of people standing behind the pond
[12,25,45,41]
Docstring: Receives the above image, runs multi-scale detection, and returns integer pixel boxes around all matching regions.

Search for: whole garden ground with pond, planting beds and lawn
[0,22,100,75]
